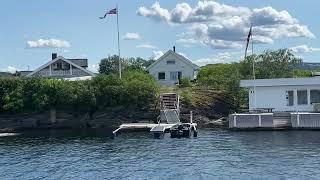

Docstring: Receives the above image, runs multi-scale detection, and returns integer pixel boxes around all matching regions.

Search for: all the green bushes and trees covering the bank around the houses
[0,49,311,124]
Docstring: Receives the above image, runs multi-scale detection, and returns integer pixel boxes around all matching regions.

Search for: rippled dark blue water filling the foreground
[0,129,320,179]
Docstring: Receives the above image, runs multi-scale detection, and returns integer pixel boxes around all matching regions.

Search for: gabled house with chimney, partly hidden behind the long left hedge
[25,53,95,78]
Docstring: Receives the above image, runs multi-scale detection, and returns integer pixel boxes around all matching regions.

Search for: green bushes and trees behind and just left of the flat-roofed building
[198,49,311,111]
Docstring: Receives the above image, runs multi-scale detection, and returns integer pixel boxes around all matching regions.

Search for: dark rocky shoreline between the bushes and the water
[0,108,226,133]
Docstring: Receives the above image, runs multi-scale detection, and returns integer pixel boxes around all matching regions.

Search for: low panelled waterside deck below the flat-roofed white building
[228,112,320,130]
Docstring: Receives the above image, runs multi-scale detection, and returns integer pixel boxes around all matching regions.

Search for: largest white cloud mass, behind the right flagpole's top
[137,1,315,49]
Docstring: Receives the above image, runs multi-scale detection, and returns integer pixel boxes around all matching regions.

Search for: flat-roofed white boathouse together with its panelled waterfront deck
[229,76,320,129]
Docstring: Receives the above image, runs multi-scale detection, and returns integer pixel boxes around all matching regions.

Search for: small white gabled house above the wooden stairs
[147,47,199,86]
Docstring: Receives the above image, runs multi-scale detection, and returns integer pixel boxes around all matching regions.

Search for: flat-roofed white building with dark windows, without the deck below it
[240,77,320,112]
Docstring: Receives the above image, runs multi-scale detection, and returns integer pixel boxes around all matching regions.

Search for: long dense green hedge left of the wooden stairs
[0,70,159,113]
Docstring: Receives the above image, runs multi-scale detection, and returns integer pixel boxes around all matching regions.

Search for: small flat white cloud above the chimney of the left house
[27,39,70,48]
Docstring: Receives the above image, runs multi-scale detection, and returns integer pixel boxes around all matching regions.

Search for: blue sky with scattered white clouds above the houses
[0,0,320,72]
